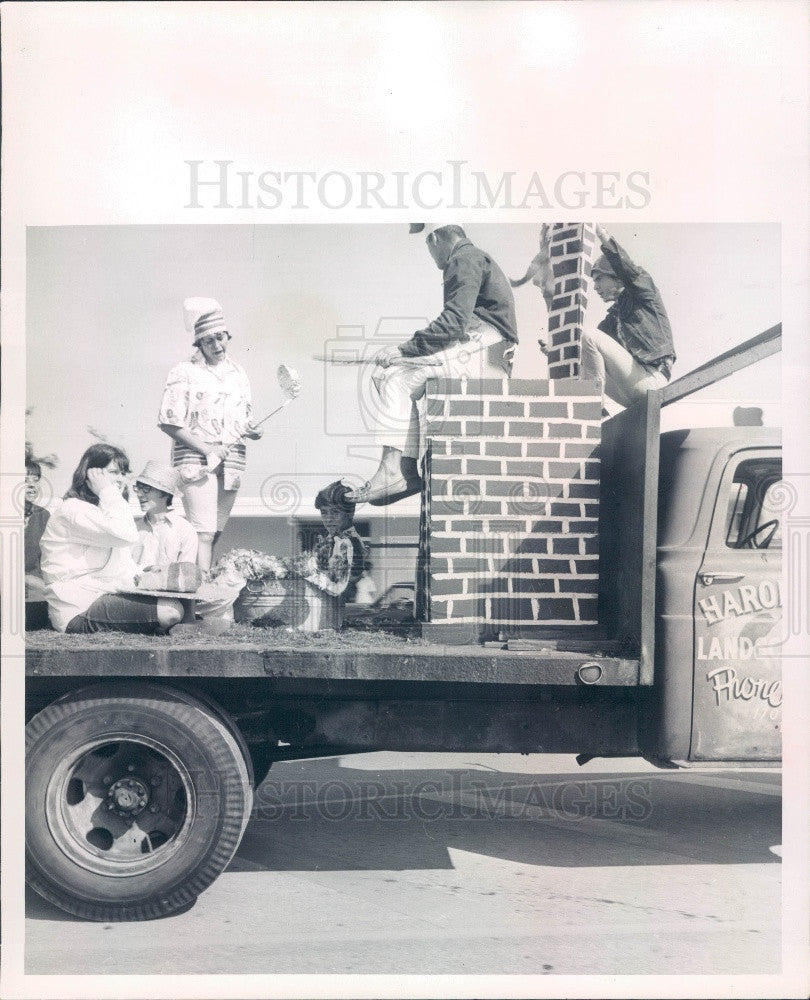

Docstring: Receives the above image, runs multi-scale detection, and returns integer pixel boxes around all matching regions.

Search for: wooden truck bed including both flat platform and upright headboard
[26,393,660,688]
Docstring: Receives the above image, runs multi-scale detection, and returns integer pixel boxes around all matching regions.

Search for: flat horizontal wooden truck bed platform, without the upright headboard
[26,626,639,687]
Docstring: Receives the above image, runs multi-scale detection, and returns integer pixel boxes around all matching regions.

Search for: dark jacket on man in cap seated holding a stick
[399,240,517,358]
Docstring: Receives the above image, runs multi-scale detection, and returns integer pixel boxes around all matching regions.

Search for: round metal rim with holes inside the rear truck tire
[45,733,196,877]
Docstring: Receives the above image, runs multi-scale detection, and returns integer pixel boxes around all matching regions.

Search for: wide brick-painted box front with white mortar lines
[423,379,601,634]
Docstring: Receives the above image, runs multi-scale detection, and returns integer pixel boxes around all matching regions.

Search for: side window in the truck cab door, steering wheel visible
[726,458,782,549]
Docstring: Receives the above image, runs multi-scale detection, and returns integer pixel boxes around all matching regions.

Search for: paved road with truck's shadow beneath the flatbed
[26,753,781,975]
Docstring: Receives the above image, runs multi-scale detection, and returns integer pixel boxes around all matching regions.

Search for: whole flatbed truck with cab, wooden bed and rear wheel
[26,328,782,921]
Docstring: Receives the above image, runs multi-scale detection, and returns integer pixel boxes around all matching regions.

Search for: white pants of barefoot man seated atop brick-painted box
[371,325,512,458]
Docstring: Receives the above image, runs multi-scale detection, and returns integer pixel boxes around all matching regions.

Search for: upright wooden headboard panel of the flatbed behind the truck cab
[599,392,661,685]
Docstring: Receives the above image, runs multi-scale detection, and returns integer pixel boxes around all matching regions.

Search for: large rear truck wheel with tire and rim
[26,683,252,921]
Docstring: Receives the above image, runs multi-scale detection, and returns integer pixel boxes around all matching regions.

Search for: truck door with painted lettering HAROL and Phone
[690,449,782,761]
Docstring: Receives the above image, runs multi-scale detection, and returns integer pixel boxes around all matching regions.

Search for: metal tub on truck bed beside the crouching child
[233,579,343,632]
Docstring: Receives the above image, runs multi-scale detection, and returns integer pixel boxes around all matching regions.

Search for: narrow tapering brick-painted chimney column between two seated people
[548,222,597,379]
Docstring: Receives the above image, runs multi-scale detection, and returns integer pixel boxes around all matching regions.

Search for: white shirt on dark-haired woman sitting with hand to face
[40,485,138,632]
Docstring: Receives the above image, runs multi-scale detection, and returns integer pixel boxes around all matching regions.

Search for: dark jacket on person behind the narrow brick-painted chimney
[599,240,675,374]
